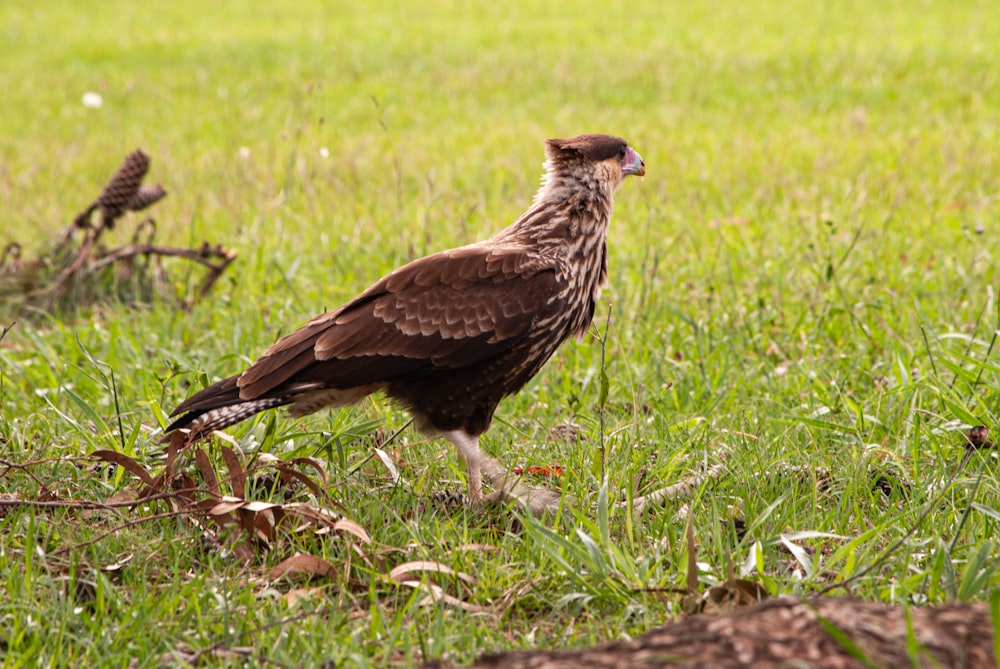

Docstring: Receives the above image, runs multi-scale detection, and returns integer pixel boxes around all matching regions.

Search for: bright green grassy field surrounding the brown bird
[0,0,1000,667]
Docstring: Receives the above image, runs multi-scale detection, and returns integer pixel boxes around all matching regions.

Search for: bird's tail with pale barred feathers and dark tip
[160,376,294,443]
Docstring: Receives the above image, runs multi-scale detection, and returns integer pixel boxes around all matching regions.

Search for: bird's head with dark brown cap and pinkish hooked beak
[545,134,646,189]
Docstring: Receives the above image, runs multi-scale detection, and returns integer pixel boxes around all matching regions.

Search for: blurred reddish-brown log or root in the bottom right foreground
[425,597,997,669]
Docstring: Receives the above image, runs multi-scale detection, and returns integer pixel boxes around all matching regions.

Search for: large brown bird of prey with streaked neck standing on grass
[164,135,646,510]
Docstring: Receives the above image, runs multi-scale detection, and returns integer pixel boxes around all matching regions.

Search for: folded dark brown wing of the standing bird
[238,244,560,399]
